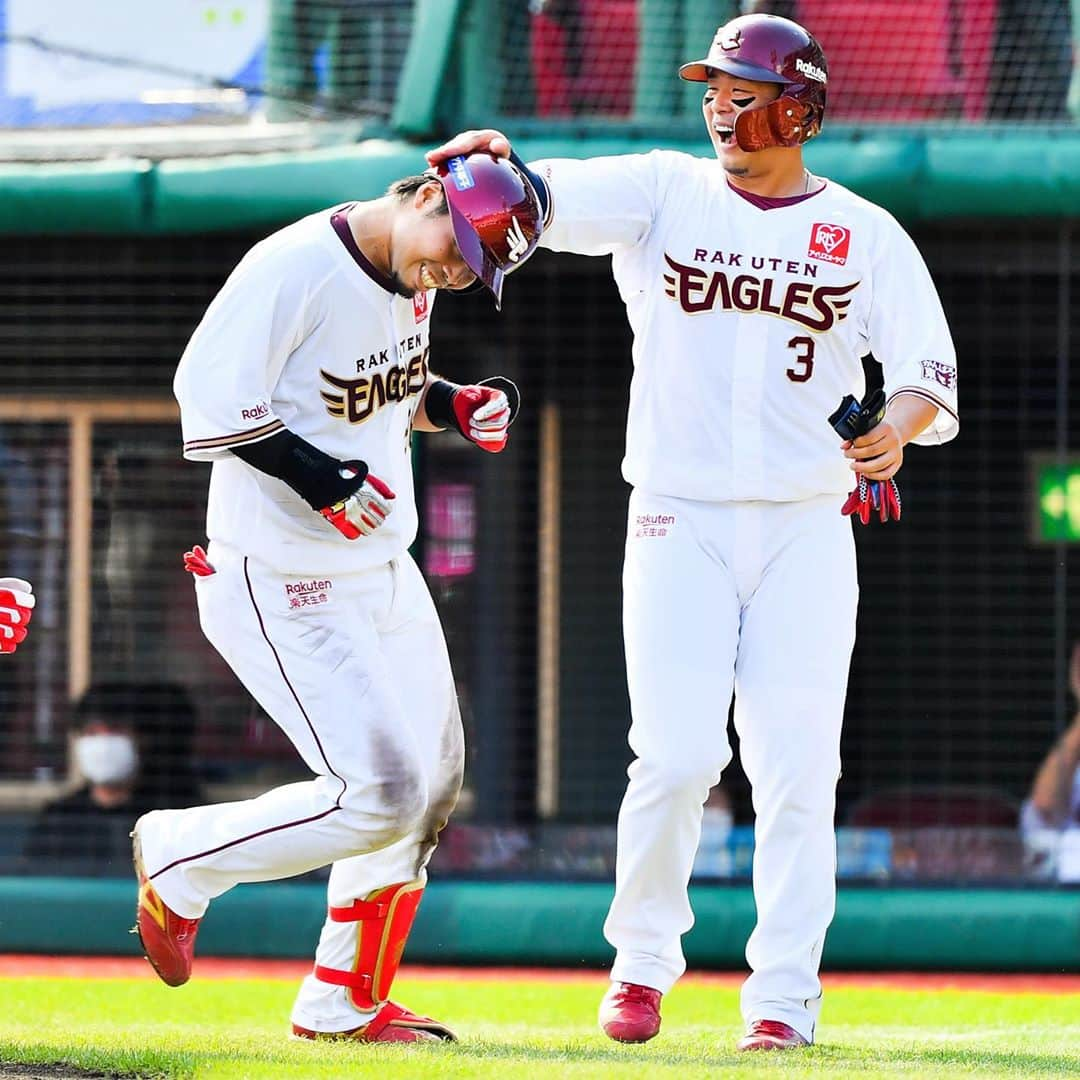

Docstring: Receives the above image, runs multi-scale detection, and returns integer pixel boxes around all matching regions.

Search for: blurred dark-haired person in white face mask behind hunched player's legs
[24,688,150,874]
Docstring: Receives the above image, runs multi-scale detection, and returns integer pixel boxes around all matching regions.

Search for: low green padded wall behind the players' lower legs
[0,878,1080,972]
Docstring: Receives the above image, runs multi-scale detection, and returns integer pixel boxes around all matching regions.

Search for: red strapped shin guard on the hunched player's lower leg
[315,878,424,1012]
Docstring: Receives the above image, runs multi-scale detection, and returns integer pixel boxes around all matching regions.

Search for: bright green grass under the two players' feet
[0,972,1080,1080]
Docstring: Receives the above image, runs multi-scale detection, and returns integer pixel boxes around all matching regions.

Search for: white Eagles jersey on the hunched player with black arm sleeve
[174,210,434,575]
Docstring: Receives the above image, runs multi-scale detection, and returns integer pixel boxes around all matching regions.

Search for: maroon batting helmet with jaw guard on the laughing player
[678,15,828,150]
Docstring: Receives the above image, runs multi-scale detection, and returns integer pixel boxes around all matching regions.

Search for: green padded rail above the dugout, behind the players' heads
[0,127,1080,234]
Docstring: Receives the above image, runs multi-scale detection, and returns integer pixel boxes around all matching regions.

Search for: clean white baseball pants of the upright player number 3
[605,490,859,1041]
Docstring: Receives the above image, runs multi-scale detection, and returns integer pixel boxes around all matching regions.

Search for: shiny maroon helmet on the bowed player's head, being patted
[435,152,543,308]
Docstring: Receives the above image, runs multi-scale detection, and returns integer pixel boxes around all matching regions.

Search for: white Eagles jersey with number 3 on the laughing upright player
[530,150,957,501]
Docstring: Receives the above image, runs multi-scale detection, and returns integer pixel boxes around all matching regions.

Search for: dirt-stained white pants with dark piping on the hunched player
[132,540,463,1031]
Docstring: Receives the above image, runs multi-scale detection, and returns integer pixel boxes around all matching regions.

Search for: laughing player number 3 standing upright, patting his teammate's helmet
[429,15,957,1050]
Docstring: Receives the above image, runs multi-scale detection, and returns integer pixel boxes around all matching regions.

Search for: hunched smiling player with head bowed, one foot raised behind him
[133,154,541,1042]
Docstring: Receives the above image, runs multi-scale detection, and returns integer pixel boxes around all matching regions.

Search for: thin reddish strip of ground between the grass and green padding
[0,955,1080,995]
